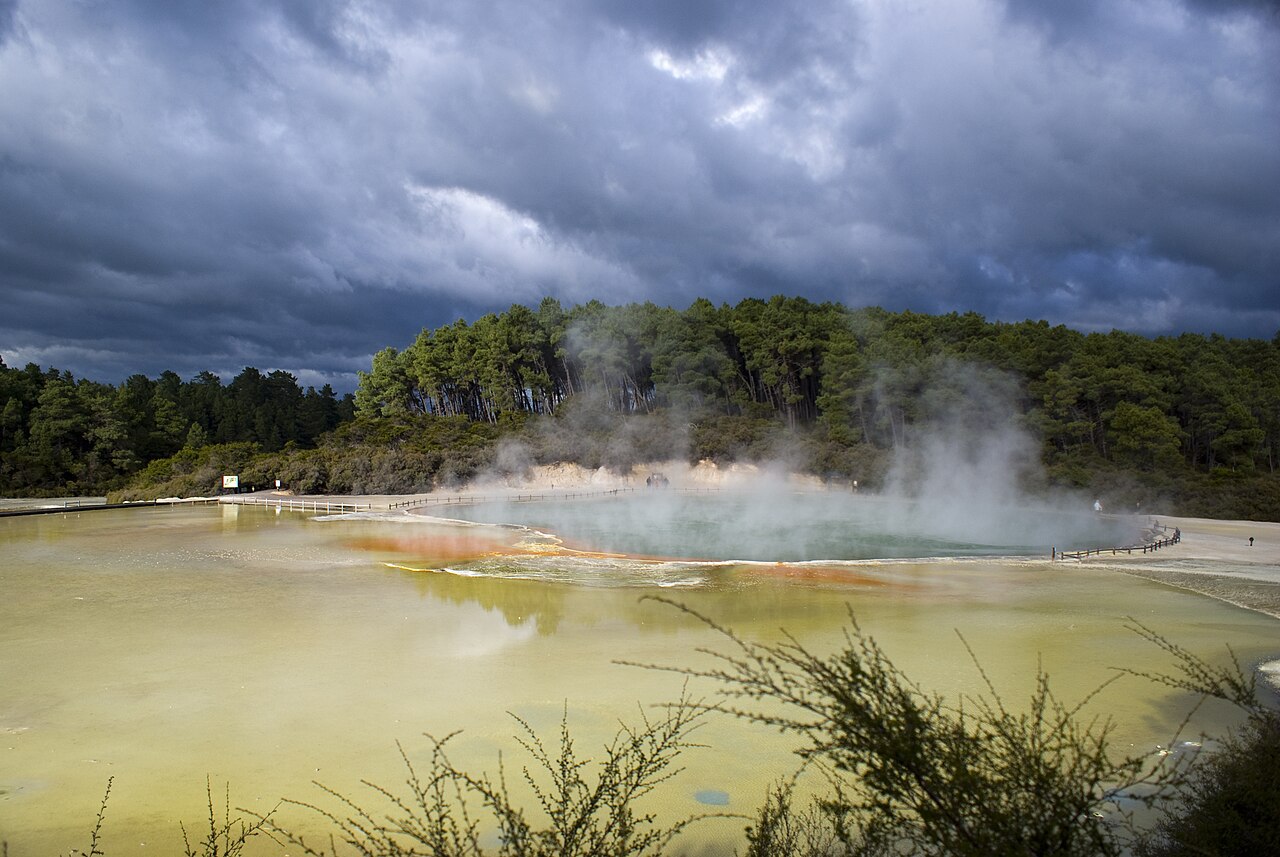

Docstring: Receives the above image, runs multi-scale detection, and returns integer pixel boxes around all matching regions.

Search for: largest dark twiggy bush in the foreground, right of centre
[650,605,1198,857]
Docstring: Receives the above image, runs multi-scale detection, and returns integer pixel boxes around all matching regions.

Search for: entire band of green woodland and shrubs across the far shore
[10,297,1280,519]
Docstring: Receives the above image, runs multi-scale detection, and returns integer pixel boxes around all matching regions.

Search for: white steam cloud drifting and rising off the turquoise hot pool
[463,361,1138,560]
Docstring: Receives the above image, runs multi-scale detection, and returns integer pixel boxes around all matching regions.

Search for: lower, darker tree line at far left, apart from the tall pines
[0,359,355,495]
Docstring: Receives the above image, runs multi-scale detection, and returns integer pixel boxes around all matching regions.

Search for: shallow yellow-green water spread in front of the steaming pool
[0,507,1280,857]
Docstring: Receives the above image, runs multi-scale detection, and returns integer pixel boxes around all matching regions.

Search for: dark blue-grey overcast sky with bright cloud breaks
[0,0,1280,390]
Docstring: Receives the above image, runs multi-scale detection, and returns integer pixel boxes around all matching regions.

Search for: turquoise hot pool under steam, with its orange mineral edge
[330,489,1137,585]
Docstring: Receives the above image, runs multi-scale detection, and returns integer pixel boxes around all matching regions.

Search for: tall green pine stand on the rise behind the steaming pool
[356,295,1280,481]
